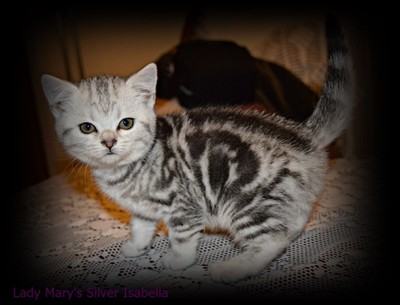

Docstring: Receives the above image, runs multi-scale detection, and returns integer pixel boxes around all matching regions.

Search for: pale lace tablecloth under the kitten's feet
[16,159,381,298]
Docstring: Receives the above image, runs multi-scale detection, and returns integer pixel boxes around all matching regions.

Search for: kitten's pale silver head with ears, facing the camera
[42,64,157,168]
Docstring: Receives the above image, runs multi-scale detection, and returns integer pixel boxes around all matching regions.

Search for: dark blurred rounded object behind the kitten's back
[156,39,318,121]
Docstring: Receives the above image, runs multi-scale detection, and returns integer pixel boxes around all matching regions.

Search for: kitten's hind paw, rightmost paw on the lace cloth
[208,261,247,283]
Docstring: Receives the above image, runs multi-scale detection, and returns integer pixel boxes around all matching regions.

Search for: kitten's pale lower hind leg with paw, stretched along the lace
[209,234,289,283]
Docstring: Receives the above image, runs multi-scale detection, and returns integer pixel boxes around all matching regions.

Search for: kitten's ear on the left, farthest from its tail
[42,74,78,118]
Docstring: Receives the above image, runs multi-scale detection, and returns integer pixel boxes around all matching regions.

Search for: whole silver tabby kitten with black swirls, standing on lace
[42,18,353,282]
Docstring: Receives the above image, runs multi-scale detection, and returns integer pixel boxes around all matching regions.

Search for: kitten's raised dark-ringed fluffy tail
[305,16,354,148]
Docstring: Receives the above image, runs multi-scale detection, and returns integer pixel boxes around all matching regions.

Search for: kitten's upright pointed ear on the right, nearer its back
[126,63,157,96]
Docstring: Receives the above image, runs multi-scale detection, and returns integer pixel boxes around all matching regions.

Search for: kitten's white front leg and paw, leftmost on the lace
[122,216,157,257]
